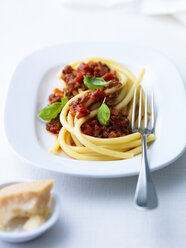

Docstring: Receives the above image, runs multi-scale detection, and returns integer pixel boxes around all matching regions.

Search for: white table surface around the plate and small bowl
[0,0,186,248]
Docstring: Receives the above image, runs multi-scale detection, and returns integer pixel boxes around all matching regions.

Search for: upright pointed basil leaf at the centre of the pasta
[97,99,110,126]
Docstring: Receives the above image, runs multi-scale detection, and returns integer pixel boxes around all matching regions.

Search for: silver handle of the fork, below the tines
[135,134,158,209]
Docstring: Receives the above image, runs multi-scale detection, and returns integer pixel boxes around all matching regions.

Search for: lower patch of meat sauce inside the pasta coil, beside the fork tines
[81,109,131,138]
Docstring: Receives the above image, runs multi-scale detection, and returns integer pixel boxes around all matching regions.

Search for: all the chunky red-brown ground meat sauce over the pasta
[46,61,130,138]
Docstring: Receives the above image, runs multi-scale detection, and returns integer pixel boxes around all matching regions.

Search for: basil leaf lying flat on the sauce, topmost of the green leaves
[83,76,110,90]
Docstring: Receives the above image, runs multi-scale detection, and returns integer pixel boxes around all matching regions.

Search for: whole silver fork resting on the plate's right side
[131,88,158,209]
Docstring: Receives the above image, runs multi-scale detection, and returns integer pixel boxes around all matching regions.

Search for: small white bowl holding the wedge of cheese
[0,180,61,243]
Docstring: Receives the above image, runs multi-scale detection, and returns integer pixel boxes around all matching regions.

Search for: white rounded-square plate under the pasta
[4,43,186,177]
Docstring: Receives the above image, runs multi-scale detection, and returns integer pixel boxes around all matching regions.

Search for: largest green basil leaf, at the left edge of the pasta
[38,93,68,121]
